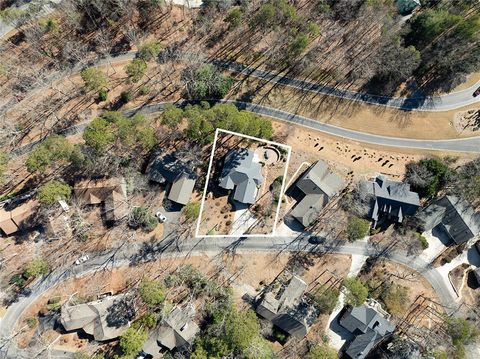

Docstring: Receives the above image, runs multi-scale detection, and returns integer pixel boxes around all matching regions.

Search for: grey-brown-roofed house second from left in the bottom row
[143,305,200,358]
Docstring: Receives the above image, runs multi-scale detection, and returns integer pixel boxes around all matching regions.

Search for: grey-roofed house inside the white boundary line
[219,148,264,204]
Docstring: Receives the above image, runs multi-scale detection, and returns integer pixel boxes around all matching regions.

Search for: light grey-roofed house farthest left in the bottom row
[60,294,130,341]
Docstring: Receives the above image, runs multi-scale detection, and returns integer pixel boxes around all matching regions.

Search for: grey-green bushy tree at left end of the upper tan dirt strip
[183,64,233,100]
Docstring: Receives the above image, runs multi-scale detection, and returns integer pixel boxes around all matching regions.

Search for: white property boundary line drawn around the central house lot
[195,128,292,238]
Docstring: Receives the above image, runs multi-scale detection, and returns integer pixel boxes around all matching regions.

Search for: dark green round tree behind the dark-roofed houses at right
[405,157,454,198]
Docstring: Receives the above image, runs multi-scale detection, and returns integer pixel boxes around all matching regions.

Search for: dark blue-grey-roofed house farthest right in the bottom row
[339,300,395,359]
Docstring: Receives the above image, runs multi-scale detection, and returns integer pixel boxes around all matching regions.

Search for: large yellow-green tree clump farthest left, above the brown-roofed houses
[25,135,83,173]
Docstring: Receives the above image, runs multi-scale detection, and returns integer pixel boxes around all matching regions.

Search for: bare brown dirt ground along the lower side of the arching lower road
[16,252,351,350]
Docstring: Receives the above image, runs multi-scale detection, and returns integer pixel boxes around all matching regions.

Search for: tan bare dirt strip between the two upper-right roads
[232,79,479,139]
